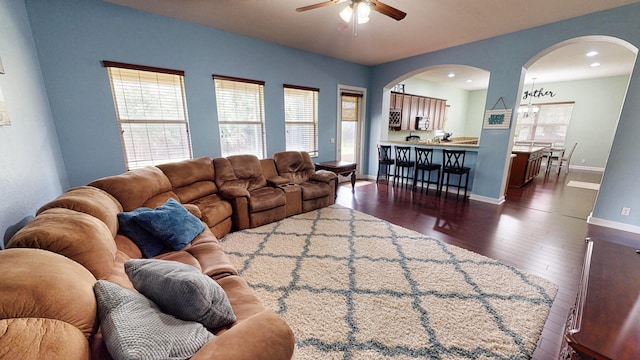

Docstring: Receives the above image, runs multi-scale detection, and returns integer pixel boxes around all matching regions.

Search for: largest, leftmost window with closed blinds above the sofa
[103,61,192,170]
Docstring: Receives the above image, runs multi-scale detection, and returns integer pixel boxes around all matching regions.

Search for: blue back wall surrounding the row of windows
[26,0,369,186]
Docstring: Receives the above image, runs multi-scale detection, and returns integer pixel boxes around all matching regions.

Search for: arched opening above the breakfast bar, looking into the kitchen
[381,64,490,142]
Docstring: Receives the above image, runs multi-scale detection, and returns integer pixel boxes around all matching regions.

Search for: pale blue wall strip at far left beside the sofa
[0,0,68,248]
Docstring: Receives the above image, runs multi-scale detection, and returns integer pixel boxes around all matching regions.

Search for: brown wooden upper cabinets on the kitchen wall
[389,92,447,130]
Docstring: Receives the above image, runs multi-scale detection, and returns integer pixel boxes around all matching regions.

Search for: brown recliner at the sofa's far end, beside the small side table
[268,151,338,212]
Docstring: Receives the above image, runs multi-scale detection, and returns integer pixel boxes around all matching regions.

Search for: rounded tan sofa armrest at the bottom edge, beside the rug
[191,311,295,360]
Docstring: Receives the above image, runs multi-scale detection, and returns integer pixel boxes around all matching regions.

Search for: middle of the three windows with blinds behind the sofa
[213,75,266,159]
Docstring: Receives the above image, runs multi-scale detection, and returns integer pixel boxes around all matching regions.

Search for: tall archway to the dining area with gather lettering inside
[506,36,638,218]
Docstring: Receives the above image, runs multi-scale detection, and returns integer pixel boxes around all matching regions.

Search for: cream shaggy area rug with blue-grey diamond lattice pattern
[221,205,557,360]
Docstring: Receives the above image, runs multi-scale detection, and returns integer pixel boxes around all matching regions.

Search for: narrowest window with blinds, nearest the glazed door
[284,84,320,156]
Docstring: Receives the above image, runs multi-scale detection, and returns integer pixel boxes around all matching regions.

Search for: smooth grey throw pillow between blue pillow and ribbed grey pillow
[124,259,236,329]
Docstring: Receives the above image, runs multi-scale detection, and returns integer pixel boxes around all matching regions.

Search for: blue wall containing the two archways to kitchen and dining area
[368,4,640,231]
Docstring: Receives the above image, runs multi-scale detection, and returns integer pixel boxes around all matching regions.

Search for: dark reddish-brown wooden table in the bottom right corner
[561,239,640,360]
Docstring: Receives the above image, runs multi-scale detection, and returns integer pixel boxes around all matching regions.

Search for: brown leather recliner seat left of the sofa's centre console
[213,155,286,230]
